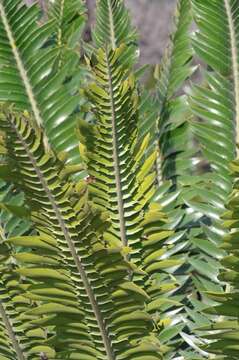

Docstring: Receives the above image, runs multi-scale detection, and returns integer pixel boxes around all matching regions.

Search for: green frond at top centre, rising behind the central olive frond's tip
[93,0,139,64]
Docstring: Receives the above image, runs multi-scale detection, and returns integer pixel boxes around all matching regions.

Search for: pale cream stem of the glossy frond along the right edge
[224,0,239,150]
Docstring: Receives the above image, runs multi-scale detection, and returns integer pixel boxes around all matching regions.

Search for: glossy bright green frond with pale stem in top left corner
[0,0,83,169]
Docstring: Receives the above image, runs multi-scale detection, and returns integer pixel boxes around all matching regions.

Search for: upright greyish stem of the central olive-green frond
[106,51,127,246]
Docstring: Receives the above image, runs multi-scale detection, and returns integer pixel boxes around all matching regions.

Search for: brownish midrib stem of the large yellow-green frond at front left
[11,122,115,360]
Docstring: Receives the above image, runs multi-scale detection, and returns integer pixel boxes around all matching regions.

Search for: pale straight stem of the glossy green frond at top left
[0,3,43,126]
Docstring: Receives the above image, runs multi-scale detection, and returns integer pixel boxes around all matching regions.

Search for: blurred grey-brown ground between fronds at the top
[25,0,176,64]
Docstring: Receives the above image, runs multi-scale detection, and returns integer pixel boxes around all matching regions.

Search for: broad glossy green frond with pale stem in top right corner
[191,0,239,177]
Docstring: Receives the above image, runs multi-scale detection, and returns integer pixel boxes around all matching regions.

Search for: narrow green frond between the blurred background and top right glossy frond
[140,0,195,149]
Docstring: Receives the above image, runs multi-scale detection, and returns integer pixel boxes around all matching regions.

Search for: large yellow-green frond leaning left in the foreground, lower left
[1,109,161,360]
